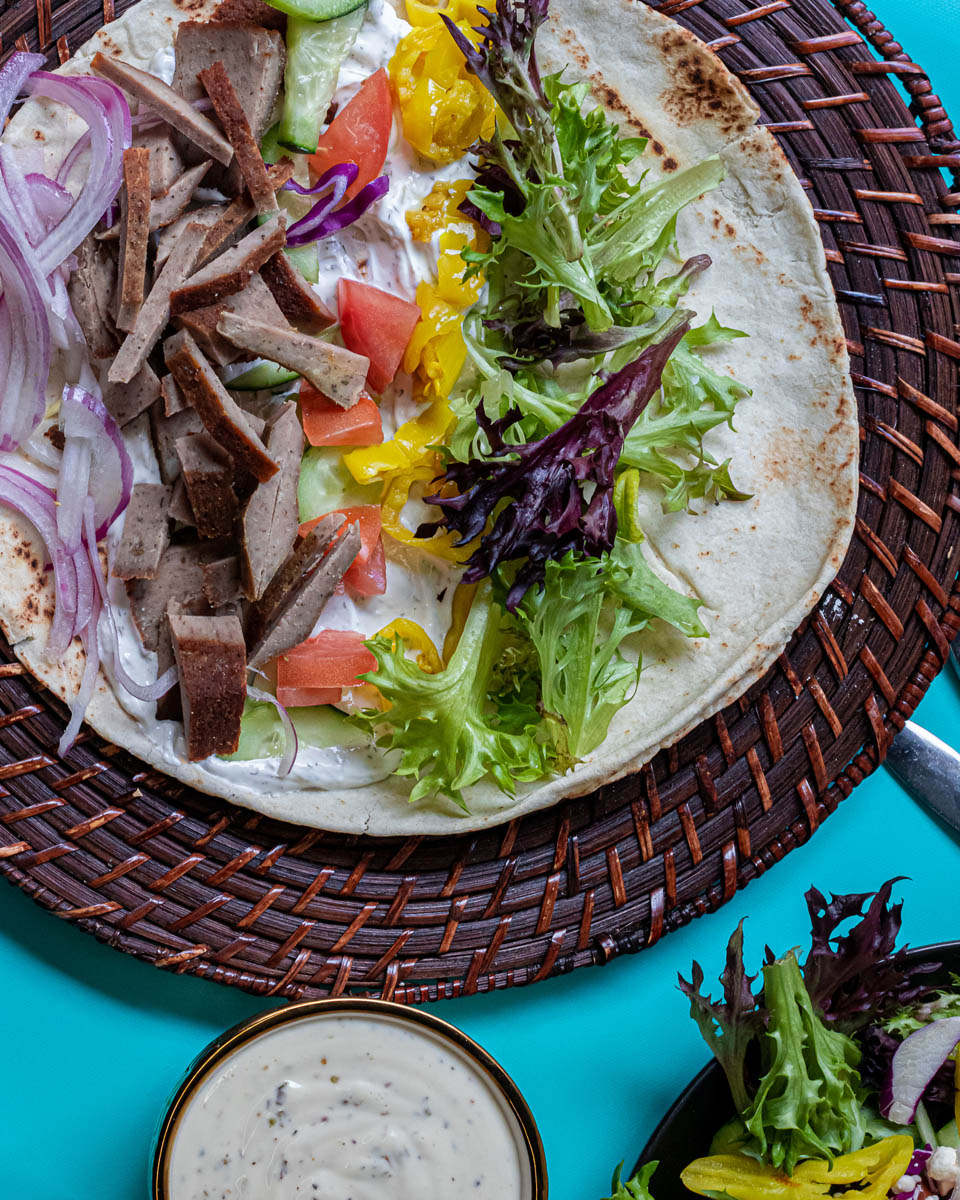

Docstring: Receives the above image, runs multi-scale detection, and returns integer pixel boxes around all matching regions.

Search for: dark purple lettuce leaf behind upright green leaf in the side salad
[803,878,940,1033]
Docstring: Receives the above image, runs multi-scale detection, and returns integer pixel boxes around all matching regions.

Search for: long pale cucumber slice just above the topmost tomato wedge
[277,0,366,154]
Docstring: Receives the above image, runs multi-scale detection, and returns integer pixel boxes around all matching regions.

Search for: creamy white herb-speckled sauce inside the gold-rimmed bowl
[167,1014,533,1200]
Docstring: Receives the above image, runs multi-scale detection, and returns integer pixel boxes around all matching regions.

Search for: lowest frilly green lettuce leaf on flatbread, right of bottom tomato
[354,588,553,811]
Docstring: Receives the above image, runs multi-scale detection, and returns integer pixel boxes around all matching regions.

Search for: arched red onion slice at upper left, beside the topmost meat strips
[24,71,132,275]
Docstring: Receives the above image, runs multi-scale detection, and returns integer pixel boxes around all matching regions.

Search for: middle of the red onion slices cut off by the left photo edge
[0,217,50,450]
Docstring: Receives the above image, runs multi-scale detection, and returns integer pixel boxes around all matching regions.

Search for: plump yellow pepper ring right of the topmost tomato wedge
[390,16,496,163]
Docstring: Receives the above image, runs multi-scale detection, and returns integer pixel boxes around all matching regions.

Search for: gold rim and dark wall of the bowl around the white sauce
[150,997,547,1200]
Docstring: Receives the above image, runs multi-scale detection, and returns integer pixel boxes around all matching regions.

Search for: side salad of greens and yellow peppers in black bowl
[600,880,960,1200]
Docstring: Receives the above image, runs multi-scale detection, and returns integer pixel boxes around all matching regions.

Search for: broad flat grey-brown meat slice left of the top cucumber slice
[173,19,287,142]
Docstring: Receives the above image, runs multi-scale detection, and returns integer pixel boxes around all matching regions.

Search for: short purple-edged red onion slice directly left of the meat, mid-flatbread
[58,386,133,539]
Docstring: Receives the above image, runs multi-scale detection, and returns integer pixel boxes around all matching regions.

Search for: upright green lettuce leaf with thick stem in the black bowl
[743,952,864,1175]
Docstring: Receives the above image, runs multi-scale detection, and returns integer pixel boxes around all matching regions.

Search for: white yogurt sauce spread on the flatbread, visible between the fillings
[93,0,469,791]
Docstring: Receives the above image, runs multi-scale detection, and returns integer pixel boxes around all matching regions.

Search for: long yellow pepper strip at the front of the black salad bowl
[680,1135,913,1200]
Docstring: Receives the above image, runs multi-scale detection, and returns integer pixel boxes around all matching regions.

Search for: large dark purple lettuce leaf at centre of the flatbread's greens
[418,311,689,612]
